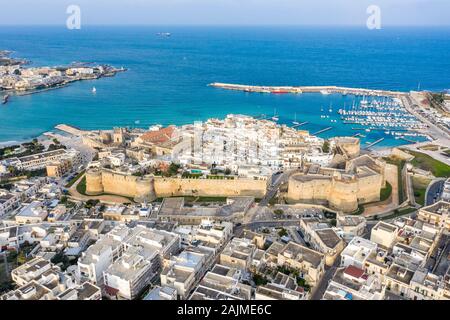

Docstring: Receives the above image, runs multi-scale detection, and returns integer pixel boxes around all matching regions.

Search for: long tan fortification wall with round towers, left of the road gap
[86,168,267,202]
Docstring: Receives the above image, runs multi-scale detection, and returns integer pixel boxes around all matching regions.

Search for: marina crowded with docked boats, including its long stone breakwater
[209,83,431,148]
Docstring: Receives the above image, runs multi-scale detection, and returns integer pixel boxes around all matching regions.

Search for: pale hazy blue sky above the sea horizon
[0,0,450,26]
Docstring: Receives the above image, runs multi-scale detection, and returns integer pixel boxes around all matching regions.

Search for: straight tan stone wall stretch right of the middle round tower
[154,177,267,198]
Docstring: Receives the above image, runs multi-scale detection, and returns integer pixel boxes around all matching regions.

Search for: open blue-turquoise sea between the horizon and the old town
[0,27,450,145]
